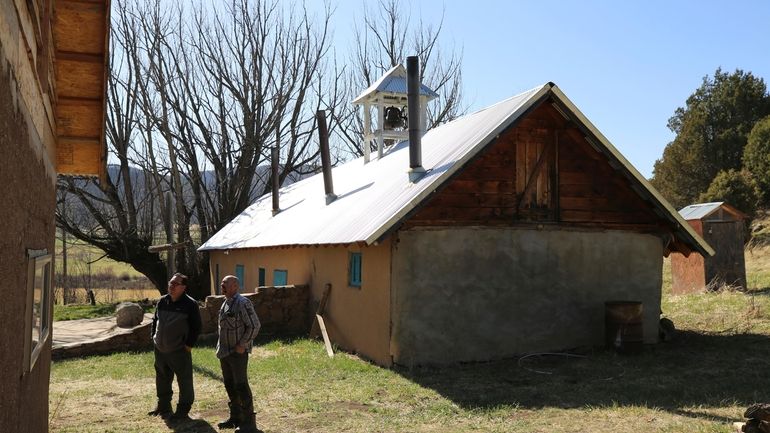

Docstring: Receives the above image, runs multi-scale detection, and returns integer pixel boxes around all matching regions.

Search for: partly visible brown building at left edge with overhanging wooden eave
[0,0,110,433]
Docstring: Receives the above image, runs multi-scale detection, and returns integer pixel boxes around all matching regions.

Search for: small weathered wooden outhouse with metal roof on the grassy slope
[671,202,746,293]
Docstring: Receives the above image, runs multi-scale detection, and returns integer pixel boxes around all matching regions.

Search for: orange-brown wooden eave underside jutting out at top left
[53,0,110,181]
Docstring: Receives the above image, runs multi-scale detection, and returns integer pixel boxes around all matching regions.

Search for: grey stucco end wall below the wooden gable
[391,228,663,365]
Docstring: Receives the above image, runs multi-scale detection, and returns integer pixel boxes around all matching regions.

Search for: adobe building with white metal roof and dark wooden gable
[201,70,713,366]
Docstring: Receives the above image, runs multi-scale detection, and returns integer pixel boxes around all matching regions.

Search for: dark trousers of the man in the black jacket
[155,348,195,411]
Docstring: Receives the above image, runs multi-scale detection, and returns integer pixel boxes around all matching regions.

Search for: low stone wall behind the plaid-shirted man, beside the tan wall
[201,285,310,335]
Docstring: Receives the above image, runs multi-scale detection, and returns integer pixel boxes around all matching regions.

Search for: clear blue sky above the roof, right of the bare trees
[320,0,770,178]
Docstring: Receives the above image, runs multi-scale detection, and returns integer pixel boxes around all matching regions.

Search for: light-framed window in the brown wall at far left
[24,250,53,371]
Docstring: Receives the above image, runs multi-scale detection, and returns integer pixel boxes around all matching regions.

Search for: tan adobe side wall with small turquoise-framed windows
[210,240,392,365]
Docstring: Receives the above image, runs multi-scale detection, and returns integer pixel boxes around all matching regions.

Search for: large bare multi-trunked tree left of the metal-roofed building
[57,0,344,297]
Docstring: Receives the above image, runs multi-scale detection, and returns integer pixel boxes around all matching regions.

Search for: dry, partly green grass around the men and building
[50,223,770,433]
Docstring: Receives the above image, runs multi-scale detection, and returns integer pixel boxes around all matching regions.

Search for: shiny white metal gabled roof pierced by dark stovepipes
[199,83,714,255]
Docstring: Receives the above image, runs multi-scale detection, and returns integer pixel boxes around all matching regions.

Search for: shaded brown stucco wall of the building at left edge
[0,13,56,433]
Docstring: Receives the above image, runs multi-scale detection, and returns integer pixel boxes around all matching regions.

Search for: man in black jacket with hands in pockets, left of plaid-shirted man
[148,273,201,420]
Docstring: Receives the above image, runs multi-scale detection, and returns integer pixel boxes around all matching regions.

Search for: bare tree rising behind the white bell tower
[332,0,466,156]
